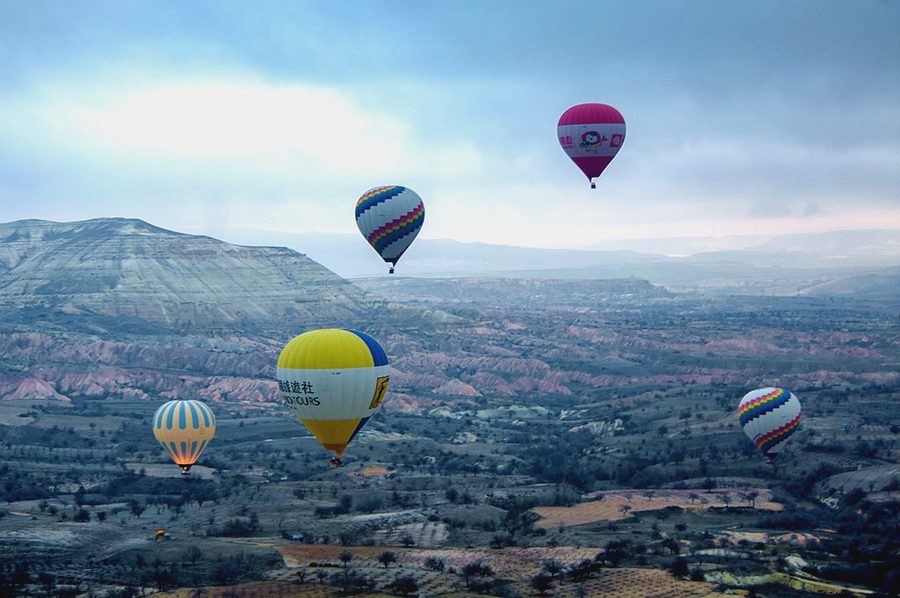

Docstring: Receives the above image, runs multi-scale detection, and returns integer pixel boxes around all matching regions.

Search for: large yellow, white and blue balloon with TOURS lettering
[277,328,388,467]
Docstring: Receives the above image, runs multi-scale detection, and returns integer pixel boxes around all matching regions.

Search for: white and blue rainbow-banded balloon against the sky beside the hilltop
[356,185,425,274]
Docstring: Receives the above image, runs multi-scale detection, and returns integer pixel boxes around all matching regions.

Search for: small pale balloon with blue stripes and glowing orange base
[153,399,216,475]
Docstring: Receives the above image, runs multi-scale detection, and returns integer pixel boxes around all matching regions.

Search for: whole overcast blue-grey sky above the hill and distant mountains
[0,0,900,247]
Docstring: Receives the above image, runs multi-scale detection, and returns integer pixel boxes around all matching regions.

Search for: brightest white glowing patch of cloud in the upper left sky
[50,80,413,172]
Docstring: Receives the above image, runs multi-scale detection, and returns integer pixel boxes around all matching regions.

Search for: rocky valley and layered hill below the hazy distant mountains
[0,219,900,596]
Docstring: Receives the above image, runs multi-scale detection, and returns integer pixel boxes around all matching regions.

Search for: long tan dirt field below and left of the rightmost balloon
[533,488,782,529]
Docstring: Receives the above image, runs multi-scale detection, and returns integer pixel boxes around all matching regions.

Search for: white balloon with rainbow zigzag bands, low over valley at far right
[738,387,802,464]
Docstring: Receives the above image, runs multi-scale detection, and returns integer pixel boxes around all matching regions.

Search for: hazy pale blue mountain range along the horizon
[204,229,900,295]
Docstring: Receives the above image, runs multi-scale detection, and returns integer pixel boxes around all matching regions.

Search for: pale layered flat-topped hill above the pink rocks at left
[0,218,369,333]
